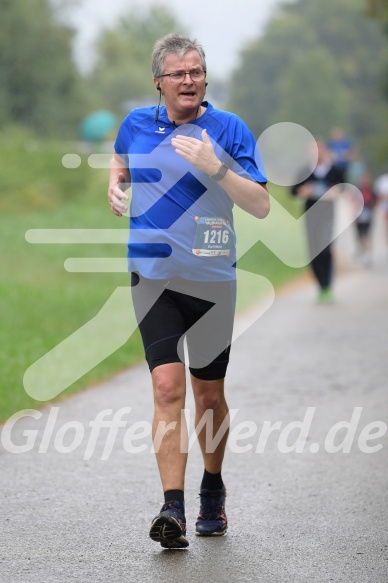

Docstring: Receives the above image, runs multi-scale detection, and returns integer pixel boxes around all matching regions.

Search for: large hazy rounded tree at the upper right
[229,0,385,147]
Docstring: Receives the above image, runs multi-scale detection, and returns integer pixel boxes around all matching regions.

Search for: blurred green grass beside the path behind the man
[0,135,306,421]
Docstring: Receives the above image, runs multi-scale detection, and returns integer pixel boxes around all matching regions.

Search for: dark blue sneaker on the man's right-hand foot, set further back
[195,487,228,536]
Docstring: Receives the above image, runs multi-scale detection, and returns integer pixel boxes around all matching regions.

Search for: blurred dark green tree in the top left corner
[0,0,88,135]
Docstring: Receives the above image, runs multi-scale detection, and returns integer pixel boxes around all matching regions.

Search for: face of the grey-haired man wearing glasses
[154,50,206,116]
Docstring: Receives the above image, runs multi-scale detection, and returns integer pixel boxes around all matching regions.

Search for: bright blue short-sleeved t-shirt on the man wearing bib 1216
[114,102,267,281]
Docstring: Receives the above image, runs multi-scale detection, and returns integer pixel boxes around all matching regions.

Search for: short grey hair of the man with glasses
[152,33,206,78]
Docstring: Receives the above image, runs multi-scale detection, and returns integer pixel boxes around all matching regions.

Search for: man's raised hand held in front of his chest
[171,129,221,176]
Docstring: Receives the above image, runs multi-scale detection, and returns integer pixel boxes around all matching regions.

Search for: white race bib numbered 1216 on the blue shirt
[193,217,234,257]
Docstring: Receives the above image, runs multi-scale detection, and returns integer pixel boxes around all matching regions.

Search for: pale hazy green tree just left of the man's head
[89,6,186,113]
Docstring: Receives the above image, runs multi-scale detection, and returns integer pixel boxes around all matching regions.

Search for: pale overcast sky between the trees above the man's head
[68,0,286,77]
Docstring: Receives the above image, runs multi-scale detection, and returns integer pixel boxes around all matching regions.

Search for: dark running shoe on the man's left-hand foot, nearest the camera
[150,500,189,549]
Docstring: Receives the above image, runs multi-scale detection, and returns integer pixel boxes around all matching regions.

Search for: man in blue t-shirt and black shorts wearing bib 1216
[108,34,269,548]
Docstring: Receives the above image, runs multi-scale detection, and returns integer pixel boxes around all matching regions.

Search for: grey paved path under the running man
[0,212,388,583]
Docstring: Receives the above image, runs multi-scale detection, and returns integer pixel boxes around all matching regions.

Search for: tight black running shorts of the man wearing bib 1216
[131,273,236,380]
